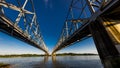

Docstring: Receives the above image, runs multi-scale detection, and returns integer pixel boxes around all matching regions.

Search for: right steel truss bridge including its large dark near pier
[52,0,120,68]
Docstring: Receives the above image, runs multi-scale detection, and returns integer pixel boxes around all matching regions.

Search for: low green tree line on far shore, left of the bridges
[0,54,45,58]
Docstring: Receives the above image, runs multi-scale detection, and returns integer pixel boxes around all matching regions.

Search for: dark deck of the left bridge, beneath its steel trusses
[0,17,48,55]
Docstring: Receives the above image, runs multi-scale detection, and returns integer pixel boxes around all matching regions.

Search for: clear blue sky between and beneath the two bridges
[0,0,97,54]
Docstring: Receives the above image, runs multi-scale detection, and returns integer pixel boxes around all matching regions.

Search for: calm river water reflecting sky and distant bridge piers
[0,56,103,68]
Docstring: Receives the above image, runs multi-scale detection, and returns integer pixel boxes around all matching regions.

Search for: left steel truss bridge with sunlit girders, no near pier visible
[0,0,49,54]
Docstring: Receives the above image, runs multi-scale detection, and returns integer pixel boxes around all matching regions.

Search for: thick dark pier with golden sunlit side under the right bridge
[89,18,120,68]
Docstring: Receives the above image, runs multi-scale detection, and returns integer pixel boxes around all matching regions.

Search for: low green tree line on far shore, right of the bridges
[56,53,98,56]
